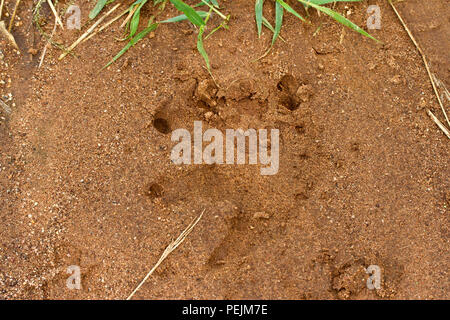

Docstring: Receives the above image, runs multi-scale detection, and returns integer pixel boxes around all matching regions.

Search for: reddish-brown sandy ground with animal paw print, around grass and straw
[0,0,450,299]
